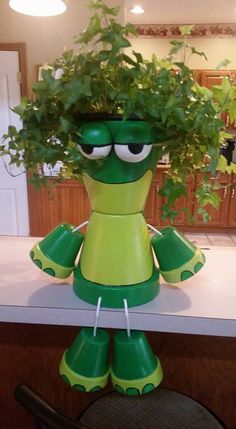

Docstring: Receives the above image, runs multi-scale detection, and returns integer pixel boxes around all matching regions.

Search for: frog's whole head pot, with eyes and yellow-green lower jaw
[74,120,161,214]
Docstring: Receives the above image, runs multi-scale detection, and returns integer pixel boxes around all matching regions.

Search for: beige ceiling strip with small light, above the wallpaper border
[124,0,236,24]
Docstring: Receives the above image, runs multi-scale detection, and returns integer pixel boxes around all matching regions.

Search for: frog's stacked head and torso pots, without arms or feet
[74,121,160,307]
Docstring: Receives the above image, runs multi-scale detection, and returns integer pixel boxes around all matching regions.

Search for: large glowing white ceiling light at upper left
[9,0,67,16]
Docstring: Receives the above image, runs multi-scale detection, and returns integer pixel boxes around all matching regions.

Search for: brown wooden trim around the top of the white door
[0,43,28,96]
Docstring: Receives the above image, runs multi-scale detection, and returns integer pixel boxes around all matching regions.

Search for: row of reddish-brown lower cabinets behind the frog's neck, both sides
[28,166,236,237]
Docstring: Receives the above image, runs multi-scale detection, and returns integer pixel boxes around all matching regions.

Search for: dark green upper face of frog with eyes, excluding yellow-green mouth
[78,121,160,184]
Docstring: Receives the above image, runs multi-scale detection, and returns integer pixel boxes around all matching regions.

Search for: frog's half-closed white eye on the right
[114,143,152,162]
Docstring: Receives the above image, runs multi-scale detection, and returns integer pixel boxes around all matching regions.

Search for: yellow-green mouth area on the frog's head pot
[83,170,153,215]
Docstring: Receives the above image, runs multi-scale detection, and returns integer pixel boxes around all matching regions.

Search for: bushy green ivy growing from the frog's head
[0,0,236,219]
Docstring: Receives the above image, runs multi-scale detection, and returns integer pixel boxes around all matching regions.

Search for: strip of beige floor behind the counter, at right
[184,232,236,247]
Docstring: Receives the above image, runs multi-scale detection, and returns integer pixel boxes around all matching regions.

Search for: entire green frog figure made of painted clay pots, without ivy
[31,120,204,395]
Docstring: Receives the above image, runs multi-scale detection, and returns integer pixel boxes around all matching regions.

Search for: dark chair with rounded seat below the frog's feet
[15,385,226,429]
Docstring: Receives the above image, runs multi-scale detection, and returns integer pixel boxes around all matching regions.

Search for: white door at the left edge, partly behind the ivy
[0,49,29,235]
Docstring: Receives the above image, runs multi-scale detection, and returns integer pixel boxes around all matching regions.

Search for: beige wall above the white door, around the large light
[0,0,124,92]
